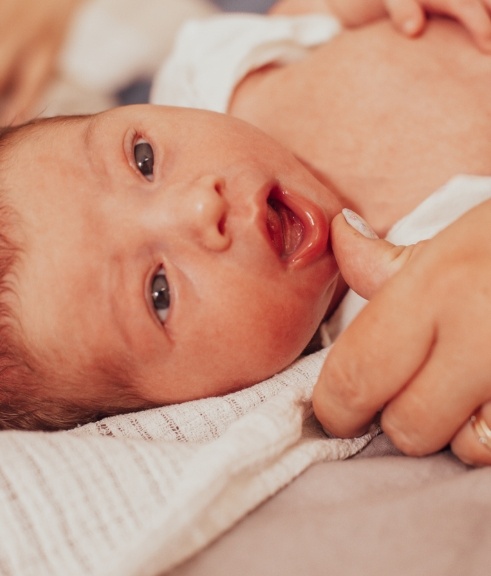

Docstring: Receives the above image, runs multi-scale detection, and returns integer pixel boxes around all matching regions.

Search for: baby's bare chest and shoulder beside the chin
[230,20,491,234]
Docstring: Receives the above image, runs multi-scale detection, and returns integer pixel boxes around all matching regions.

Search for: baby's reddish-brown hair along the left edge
[0,117,156,431]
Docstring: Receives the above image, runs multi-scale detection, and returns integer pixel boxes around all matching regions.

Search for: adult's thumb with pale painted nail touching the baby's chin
[331,208,418,300]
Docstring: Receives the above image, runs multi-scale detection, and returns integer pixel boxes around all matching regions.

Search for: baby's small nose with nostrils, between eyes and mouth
[184,176,231,251]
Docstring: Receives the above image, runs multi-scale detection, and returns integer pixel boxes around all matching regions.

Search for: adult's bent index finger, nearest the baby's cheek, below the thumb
[313,274,435,437]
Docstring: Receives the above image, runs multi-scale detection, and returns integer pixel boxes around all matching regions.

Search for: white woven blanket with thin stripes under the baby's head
[0,352,376,576]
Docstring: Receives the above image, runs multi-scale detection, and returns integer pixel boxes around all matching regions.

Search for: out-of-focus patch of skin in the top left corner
[0,0,82,124]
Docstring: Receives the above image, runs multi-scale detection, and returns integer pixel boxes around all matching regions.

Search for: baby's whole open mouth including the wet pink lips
[266,186,329,266]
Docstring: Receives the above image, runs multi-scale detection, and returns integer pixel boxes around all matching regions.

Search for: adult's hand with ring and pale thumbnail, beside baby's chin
[314,201,491,464]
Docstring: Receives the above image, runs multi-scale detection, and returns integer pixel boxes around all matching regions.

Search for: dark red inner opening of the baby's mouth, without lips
[266,195,304,259]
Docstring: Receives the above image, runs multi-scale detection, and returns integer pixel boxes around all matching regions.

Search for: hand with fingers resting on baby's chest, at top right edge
[269,0,491,53]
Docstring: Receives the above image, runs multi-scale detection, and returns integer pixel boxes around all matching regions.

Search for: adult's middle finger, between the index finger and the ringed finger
[381,317,491,456]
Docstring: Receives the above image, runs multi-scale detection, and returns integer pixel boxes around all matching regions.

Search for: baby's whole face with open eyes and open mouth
[7,106,339,403]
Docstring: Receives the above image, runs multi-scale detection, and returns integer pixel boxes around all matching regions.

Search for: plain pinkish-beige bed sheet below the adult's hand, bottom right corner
[170,435,491,576]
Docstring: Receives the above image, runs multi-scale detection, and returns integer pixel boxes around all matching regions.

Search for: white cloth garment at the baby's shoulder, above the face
[150,14,341,112]
